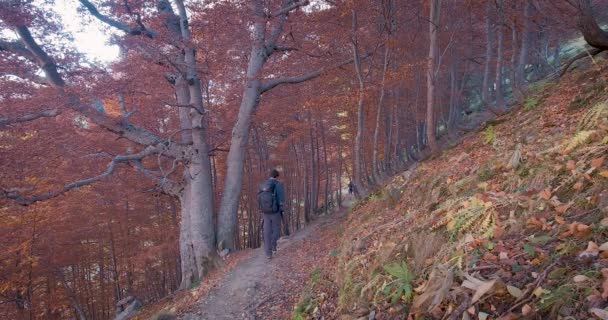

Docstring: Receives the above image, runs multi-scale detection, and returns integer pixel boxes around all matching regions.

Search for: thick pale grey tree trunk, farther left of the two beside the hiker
[176,0,217,288]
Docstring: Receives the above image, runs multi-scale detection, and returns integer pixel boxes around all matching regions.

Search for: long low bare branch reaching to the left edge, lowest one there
[0,146,158,205]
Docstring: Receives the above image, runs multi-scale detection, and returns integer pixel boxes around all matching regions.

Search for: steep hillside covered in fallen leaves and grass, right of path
[293,62,608,319]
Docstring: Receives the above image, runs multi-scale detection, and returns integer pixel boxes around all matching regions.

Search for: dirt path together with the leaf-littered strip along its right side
[173,196,350,320]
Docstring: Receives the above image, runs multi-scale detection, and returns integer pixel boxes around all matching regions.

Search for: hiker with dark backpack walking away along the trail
[258,169,285,259]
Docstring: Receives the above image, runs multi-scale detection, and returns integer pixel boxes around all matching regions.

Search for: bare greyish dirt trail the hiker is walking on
[180,201,351,320]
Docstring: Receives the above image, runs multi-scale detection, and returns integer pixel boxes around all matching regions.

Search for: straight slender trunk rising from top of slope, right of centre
[426,0,441,153]
